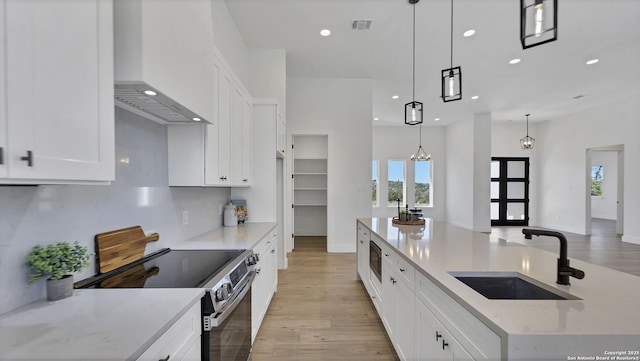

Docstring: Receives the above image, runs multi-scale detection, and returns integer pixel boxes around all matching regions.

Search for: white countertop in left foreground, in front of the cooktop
[0,289,204,361]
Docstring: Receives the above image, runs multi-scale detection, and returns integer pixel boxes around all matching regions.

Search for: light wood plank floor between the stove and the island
[252,237,398,361]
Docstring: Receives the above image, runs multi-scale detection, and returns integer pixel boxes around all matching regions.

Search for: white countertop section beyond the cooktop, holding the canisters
[171,222,277,249]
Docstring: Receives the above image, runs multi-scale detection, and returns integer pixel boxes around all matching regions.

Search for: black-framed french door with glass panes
[491,157,529,226]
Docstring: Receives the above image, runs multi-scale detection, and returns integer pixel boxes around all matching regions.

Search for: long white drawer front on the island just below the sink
[415,274,501,360]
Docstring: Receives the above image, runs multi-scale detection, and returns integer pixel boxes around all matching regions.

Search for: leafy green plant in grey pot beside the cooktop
[26,242,93,301]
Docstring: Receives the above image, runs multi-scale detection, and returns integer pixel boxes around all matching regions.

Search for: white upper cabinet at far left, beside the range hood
[0,0,115,184]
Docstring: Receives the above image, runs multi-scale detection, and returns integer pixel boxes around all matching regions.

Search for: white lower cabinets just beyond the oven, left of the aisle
[251,228,278,342]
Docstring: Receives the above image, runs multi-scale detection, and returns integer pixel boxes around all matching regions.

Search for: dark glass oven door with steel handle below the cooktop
[202,272,255,361]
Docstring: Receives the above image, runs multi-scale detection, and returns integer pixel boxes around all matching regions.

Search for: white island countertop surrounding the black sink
[359,218,640,338]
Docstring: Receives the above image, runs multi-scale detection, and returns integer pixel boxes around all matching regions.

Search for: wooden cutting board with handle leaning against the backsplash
[94,226,160,273]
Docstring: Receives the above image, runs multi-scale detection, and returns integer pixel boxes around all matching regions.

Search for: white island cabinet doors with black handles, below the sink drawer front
[414,301,473,361]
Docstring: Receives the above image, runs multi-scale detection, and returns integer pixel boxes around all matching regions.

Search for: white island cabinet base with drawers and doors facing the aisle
[357,222,501,361]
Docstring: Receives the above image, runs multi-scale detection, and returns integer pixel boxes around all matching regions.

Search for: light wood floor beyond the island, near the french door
[491,218,640,276]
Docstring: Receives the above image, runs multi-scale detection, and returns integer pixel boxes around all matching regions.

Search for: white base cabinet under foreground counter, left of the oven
[137,302,201,361]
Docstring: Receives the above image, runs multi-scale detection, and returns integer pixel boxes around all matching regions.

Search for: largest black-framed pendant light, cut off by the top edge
[520,0,558,49]
